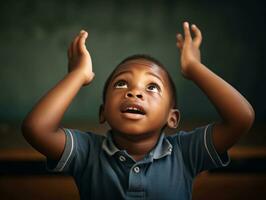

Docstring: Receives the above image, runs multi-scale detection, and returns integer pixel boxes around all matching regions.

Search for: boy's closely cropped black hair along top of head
[102,54,177,108]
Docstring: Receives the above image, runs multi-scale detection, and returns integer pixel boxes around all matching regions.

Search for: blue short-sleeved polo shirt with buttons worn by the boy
[47,125,230,200]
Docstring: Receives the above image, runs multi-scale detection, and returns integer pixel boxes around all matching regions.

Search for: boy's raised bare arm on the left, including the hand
[21,31,94,159]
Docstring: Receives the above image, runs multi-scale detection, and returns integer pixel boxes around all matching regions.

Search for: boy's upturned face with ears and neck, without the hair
[100,59,179,160]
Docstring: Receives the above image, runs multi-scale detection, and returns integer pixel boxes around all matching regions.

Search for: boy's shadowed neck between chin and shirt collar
[112,132,160,161]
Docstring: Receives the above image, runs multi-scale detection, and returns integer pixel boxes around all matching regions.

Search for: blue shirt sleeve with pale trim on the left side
[46,128,91,177]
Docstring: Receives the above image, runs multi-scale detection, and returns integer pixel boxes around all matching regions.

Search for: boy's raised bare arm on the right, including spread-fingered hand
[177,22,255,153]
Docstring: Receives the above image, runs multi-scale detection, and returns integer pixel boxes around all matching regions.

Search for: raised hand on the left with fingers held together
[67,30,94,85]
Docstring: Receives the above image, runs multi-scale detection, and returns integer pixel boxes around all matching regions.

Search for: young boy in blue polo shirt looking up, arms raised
[22,22,254,199]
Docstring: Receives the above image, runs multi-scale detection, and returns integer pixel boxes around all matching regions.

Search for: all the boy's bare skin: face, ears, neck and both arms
[22,22,255,160]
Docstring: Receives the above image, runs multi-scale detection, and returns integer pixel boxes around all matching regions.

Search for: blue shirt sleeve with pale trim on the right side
[179,124,230,176]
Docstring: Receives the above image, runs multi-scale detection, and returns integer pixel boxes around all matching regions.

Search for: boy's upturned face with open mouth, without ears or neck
[101,59,179,135]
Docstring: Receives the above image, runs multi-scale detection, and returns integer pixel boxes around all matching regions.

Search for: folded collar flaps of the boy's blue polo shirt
[102,131,173,159]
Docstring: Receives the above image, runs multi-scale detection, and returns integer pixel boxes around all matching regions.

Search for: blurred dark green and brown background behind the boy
[0,0,266,199]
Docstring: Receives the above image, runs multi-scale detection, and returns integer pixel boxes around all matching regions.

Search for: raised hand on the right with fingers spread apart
[176,22,202,79]
